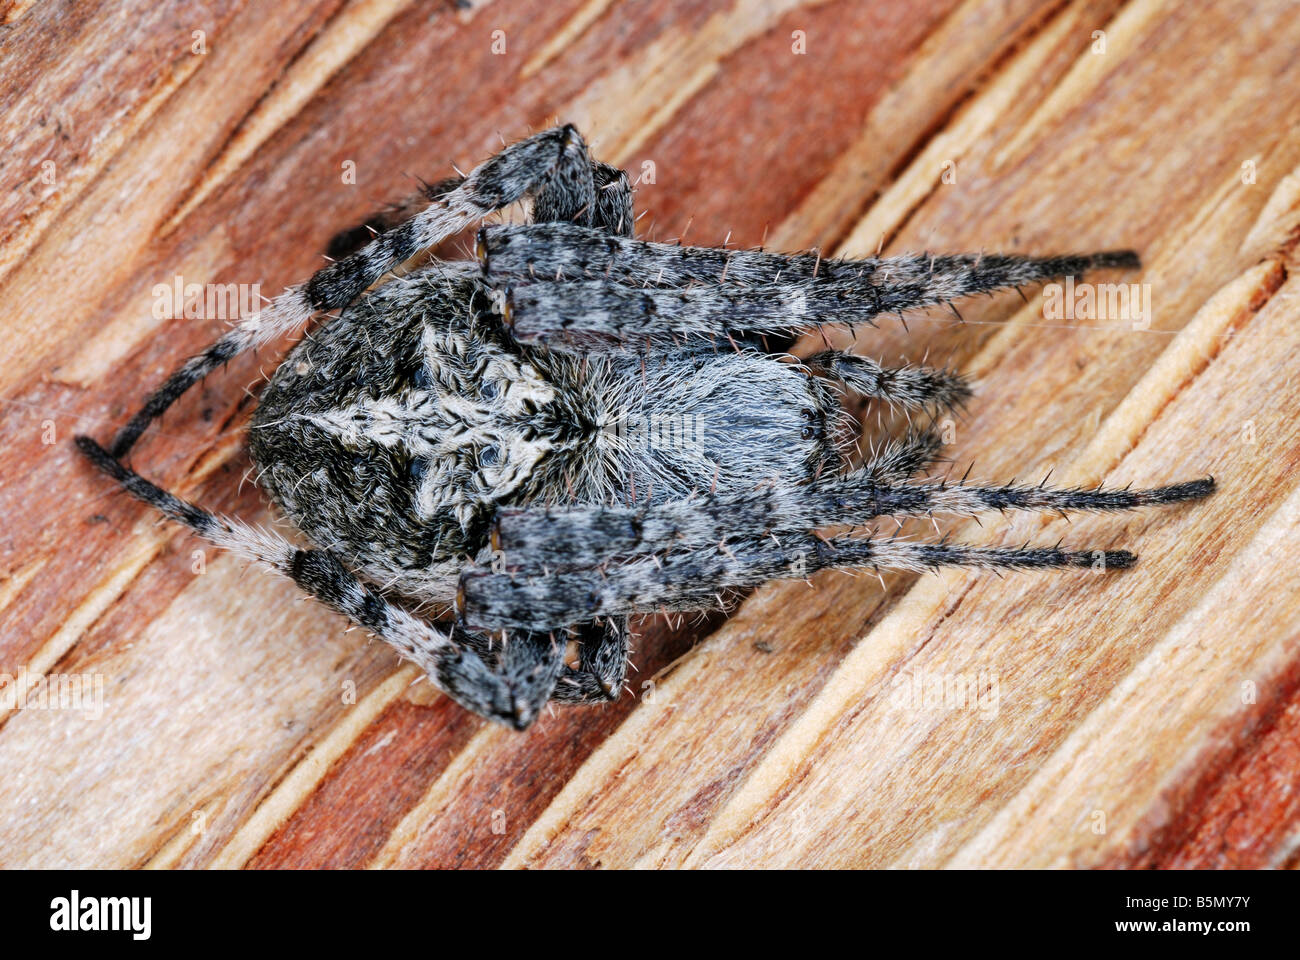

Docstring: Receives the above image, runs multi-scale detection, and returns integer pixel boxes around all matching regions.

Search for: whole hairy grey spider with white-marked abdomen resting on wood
[77,126,1214,730]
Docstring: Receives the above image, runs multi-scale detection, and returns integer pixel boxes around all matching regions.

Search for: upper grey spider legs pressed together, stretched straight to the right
[478,224,1138,350]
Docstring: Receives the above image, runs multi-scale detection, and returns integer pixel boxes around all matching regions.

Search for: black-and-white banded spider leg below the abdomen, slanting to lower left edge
[77,437,564,730]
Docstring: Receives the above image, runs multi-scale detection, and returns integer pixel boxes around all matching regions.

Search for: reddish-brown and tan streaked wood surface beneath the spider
[0,0,1300,868]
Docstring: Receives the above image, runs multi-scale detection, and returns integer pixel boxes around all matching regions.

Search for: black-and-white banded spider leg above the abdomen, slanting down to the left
[109,126,593,458]
